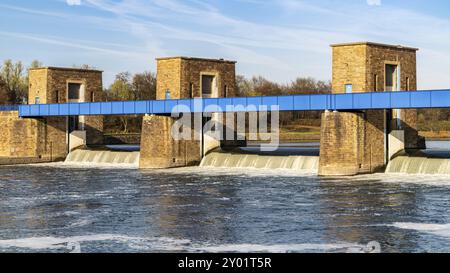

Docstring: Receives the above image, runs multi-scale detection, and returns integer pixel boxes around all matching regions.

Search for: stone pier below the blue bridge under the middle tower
[140,116,202,169]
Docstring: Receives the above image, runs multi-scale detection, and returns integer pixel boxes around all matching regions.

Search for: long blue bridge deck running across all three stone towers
[7,90,450,117]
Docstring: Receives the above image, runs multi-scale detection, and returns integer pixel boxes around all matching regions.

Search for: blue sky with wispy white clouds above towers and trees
[0,0,450,89]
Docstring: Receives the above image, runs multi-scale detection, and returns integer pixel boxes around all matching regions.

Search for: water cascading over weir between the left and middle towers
[65,150,140,168]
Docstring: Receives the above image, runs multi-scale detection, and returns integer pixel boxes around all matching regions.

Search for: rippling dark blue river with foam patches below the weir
[0,165,450,252]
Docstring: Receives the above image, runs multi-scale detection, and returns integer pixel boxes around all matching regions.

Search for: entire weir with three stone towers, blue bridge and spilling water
[0,42,450,176]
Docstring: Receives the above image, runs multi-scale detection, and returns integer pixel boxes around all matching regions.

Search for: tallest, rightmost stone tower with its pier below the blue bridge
[319,42,423,175]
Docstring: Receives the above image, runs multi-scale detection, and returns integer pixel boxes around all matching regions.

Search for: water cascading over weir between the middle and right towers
[200,152,319,172]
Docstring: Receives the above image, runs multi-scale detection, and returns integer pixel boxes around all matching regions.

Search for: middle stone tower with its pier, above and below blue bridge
[140,57,236,168]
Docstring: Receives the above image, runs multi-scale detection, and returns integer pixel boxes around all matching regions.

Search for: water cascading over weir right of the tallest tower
[386,156,450,174]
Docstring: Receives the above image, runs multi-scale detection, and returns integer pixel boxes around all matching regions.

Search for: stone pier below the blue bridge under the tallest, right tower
[319,110,385,176]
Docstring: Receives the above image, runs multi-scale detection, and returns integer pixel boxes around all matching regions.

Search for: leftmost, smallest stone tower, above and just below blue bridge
[28,67,103,145]
